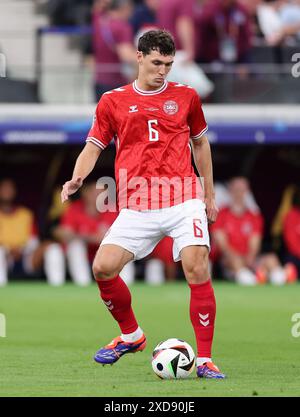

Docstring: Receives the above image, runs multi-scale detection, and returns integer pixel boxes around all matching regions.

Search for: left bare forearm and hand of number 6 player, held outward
[61,142,101,203]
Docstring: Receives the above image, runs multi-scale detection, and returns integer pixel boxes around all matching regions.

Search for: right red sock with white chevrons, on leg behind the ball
[189,280,216,358]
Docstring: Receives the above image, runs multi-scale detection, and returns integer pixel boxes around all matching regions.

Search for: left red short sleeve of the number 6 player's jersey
[86,94,115,149]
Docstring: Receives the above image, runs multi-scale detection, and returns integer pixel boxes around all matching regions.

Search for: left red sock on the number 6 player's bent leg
[96,275,138,334]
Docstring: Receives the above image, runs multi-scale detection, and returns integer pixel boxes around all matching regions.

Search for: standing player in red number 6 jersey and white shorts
[61,30,225,379]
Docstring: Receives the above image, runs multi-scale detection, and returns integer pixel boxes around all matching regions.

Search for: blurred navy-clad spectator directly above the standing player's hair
[130,0,160,34]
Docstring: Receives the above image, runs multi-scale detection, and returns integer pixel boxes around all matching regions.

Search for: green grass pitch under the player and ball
[0,282,300,397]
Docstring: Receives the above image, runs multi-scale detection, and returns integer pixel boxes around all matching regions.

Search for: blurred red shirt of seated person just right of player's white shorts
[210,207,263,255]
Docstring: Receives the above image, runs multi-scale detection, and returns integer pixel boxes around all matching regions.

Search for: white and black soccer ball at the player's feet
[152,338,195,379]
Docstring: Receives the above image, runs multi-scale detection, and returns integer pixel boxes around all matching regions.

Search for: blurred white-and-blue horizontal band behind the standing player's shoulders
[0,104,300,144]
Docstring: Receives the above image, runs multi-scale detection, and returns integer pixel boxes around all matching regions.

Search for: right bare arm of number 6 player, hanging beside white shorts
[192,136,219,223]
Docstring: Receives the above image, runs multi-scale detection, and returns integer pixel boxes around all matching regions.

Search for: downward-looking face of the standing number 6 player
[137,51,174,89]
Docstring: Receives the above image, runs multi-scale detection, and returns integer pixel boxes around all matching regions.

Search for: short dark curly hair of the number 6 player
[138,30,176,55]
